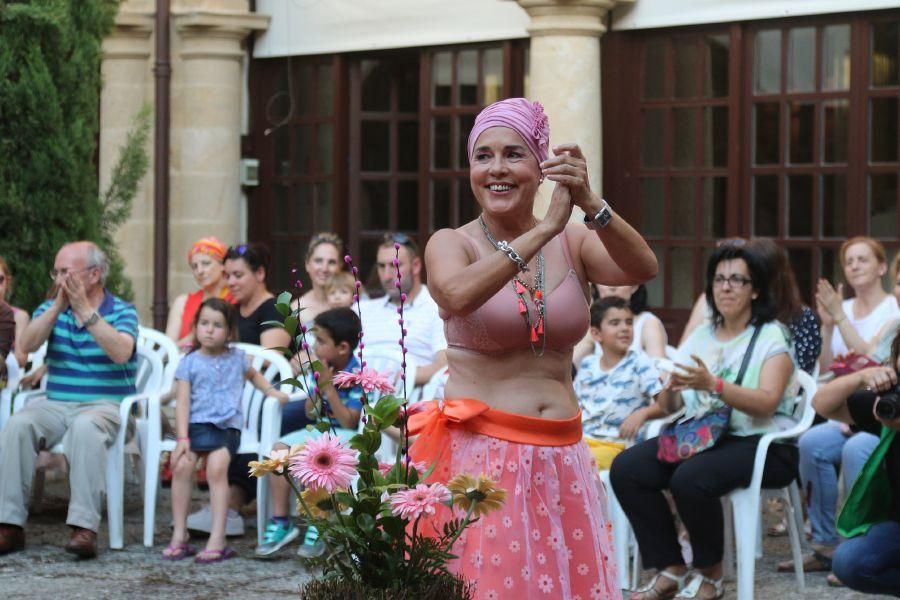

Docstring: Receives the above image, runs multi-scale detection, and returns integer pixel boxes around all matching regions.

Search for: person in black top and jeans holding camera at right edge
[813,336,900,596]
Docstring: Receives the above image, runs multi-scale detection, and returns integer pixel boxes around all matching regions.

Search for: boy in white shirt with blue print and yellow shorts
[574,296,668,470]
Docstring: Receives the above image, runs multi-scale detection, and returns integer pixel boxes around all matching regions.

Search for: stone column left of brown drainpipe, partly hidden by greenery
[99,0,153,323]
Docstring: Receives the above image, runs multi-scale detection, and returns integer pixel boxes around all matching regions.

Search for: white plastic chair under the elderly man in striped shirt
[13,336,165,550]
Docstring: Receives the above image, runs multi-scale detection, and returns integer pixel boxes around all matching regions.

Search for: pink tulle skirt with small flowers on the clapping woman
[428,428,621,600]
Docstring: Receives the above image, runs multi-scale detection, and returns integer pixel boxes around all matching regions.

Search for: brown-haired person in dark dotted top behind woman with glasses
[747,238,822,375]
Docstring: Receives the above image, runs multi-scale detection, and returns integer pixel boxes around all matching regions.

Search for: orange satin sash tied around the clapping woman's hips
[407,398,582,472]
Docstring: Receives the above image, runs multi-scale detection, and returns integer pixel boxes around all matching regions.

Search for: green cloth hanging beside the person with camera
[837,427,897,538]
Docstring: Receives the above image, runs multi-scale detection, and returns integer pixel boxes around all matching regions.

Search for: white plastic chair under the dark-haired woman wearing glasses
[723,369,816,600]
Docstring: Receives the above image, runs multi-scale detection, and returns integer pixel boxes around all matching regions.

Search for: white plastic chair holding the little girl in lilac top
[141,344,306,547]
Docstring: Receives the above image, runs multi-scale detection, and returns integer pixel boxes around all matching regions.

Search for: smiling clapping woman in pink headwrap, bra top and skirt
[410,98,657,599]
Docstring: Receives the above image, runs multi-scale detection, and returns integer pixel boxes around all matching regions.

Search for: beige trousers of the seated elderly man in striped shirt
[0,399,133,531]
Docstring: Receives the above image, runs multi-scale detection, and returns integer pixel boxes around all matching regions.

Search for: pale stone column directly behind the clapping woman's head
[517,0,617,220]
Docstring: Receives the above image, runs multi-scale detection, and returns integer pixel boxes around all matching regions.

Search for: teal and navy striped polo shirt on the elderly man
[34,290,138,402]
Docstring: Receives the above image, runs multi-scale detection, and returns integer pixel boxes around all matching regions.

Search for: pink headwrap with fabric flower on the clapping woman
[468,98,550,164]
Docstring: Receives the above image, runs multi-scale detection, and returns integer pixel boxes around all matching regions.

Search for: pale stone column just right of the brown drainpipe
[169,5,269,296]
